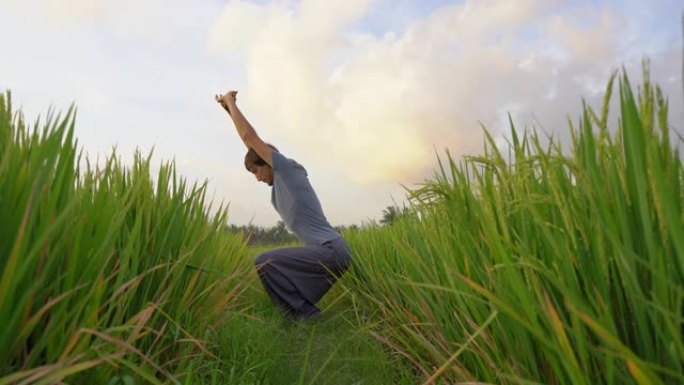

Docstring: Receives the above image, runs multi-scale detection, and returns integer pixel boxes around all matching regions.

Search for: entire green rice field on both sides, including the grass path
[0,63,684,385]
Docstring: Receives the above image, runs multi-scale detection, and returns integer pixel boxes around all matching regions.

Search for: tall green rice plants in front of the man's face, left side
[0,93,251,384]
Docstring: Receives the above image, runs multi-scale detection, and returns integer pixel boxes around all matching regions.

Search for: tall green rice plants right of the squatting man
[346,64,684,385]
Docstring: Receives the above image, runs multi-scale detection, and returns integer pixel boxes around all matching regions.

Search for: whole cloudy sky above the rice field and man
[0,0,684,226]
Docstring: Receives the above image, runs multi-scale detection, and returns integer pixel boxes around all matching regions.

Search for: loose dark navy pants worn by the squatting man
[255,237,351,319]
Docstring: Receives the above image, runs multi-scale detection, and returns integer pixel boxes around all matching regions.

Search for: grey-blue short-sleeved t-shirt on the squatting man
[271,151,340,245]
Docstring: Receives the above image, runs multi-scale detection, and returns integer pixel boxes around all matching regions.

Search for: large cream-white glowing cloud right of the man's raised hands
[209,0,656,184]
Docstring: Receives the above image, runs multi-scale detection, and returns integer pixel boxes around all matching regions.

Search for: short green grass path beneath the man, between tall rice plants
[195,250,418,385]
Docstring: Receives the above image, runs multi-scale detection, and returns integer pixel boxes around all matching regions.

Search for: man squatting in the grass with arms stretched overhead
[215,91,351,319]
